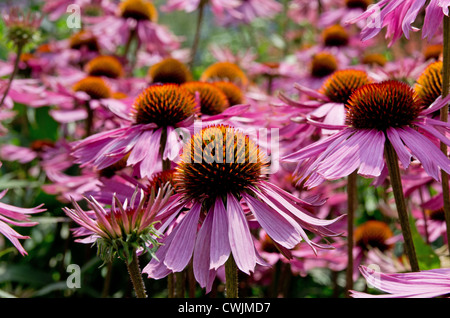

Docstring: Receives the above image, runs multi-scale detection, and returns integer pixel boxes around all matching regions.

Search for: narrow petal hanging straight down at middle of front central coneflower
[208,198,231,269]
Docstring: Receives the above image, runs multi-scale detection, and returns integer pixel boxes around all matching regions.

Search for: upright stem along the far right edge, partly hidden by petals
[440,15,450,258]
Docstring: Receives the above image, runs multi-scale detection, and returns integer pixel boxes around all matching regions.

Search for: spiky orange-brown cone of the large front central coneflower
[175,125,267,199]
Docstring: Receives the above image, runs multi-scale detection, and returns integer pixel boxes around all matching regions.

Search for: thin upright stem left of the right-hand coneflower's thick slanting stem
[346,171,358,292]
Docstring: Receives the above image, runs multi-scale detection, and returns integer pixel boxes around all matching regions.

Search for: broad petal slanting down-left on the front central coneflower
[164,203,202,272]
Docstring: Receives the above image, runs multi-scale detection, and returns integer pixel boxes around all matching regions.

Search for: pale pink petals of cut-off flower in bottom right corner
[350,266,450,298]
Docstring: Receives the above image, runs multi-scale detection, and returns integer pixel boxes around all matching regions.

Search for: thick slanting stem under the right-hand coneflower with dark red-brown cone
[384,140,420,272]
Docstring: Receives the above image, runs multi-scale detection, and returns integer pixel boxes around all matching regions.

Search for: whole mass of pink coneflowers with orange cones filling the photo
[0,0,450,297]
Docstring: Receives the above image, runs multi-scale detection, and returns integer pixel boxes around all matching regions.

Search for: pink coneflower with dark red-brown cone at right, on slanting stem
[284,81,450,187]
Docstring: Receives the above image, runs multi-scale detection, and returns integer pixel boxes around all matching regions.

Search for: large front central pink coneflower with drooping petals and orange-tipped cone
[144,125,338,292]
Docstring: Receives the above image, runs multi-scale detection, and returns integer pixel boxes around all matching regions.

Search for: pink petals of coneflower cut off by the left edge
[0,185,46,255]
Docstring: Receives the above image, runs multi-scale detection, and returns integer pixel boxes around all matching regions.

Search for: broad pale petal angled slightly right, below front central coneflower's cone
[227,194,256,275]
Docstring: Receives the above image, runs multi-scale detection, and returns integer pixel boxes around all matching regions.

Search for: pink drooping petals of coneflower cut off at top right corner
[347,0,450,45]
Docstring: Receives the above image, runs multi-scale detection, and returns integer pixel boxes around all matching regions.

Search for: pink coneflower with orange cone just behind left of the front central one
[73,84,195,178]
